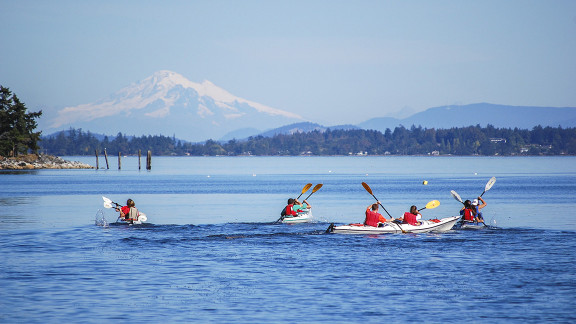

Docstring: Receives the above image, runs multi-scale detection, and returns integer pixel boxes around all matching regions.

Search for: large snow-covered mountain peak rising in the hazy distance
[43,71,304,141]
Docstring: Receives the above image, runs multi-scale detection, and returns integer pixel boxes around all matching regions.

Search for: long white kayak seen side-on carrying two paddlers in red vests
[326,216,460,234]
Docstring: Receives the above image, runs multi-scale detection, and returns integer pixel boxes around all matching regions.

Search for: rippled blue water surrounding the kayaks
[0,157,576,323]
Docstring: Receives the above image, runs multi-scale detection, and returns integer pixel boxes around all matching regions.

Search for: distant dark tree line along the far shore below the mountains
[40,125,576,156]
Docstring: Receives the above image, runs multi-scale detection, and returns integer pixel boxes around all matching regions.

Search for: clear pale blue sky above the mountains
[0,0,576,126]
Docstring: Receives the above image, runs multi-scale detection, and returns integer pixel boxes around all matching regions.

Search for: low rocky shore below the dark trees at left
[0,154,94,170]
